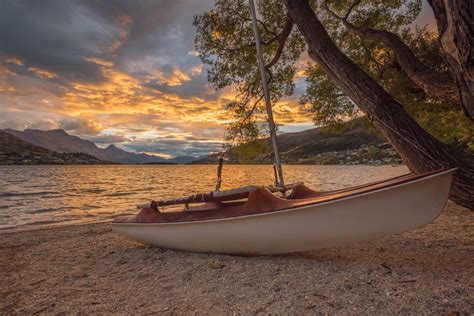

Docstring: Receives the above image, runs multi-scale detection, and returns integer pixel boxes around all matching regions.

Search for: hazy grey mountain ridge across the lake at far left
[4,129,197,164]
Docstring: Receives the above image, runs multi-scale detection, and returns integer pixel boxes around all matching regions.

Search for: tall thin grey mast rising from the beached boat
[249,0,285,188]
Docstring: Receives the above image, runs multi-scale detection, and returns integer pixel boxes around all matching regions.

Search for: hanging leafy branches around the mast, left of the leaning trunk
[194,0,304,142]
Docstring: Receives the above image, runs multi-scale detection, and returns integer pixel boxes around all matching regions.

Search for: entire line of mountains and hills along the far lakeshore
[0,119,399,164]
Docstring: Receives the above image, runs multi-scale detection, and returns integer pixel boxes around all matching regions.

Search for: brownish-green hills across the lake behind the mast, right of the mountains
[192,119,400,164]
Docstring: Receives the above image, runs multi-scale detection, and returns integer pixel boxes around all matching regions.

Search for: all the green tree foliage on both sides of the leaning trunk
[194,0,474,150]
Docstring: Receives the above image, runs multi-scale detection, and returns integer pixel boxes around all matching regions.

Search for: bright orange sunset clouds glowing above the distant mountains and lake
[0,57,309,156]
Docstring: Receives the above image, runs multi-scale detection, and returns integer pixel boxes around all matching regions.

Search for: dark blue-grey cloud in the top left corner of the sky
[0,0,118,82]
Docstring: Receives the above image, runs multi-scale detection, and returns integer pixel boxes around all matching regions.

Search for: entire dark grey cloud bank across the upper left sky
[0,0,213,82]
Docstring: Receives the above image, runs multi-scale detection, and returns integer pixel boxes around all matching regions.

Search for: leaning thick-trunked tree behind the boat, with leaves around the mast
[195,0,474,209]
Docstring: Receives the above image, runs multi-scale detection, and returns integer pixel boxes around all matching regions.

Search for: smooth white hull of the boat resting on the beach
[112,170,454,255]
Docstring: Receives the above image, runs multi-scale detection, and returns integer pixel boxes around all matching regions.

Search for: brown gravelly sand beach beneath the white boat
[0,203,474,314]
